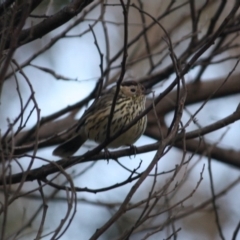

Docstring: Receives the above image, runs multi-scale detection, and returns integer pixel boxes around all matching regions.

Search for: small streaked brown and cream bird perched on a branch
[53,80,148,158]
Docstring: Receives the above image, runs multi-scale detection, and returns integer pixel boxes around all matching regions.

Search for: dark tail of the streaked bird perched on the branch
[53,134,86,157]
